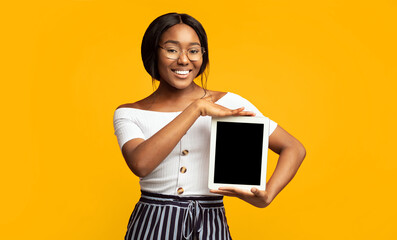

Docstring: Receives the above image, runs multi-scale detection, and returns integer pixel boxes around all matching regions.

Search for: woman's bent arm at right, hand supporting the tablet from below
[211,125,306,208]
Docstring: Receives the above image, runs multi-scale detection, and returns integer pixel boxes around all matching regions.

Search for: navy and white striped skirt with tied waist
[124,191,232,240]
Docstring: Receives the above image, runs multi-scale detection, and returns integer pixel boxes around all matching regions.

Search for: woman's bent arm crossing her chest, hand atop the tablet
[122,98,255,177]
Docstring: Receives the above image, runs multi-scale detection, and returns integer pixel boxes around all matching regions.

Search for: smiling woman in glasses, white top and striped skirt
[114,13,305,239]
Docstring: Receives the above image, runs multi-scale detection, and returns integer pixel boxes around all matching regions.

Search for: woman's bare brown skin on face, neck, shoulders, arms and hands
[116,24,306,208]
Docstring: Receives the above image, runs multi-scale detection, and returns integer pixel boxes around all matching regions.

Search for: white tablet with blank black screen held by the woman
[208,116,270,190]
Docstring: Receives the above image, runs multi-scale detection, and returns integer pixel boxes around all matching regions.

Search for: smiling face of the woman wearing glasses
[158,23,203,89]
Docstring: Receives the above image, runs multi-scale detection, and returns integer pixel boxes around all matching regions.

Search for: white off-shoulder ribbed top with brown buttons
[113,92,277,196]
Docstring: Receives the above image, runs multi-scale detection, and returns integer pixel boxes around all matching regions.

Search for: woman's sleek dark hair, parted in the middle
[141,13,209,87]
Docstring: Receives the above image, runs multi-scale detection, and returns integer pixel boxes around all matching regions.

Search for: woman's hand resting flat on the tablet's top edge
[194,96,255,117]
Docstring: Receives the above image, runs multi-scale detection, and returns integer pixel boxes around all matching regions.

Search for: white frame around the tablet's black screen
[208,116,270,190]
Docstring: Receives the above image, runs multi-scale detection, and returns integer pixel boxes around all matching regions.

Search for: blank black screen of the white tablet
[214,121,263,185]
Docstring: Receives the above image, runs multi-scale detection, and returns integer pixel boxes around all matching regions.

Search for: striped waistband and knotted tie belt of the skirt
[139,190,223,239]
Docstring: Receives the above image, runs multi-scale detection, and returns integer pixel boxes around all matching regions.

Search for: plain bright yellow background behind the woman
[0,0,397,240]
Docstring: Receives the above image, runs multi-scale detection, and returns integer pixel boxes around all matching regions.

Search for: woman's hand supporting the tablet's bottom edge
[210,187,273,208]
